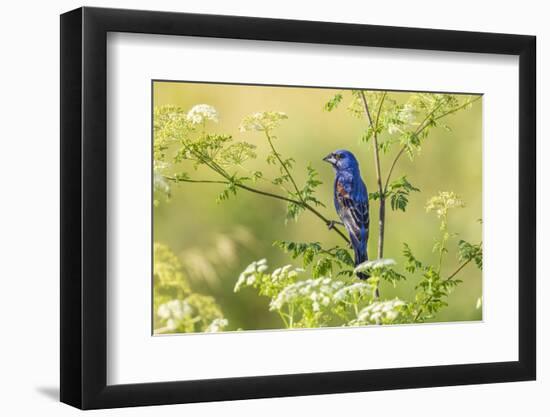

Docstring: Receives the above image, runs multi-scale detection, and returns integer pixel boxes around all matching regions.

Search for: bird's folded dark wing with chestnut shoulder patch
[335,180,369,249]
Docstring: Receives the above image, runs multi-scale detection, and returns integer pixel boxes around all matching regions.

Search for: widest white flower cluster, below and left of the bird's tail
[270,278,344,311]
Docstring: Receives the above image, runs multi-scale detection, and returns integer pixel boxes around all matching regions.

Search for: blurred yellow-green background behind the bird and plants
[153,81,482,330]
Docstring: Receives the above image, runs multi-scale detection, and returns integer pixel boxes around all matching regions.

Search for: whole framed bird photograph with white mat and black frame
[61,7,536,409]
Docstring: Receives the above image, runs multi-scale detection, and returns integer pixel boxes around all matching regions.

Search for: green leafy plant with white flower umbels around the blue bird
[154,90,482,331]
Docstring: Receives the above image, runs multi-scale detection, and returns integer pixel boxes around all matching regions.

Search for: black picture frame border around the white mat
[60,7,536,409]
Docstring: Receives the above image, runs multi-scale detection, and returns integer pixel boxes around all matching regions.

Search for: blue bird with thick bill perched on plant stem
[323,150,369,279]
